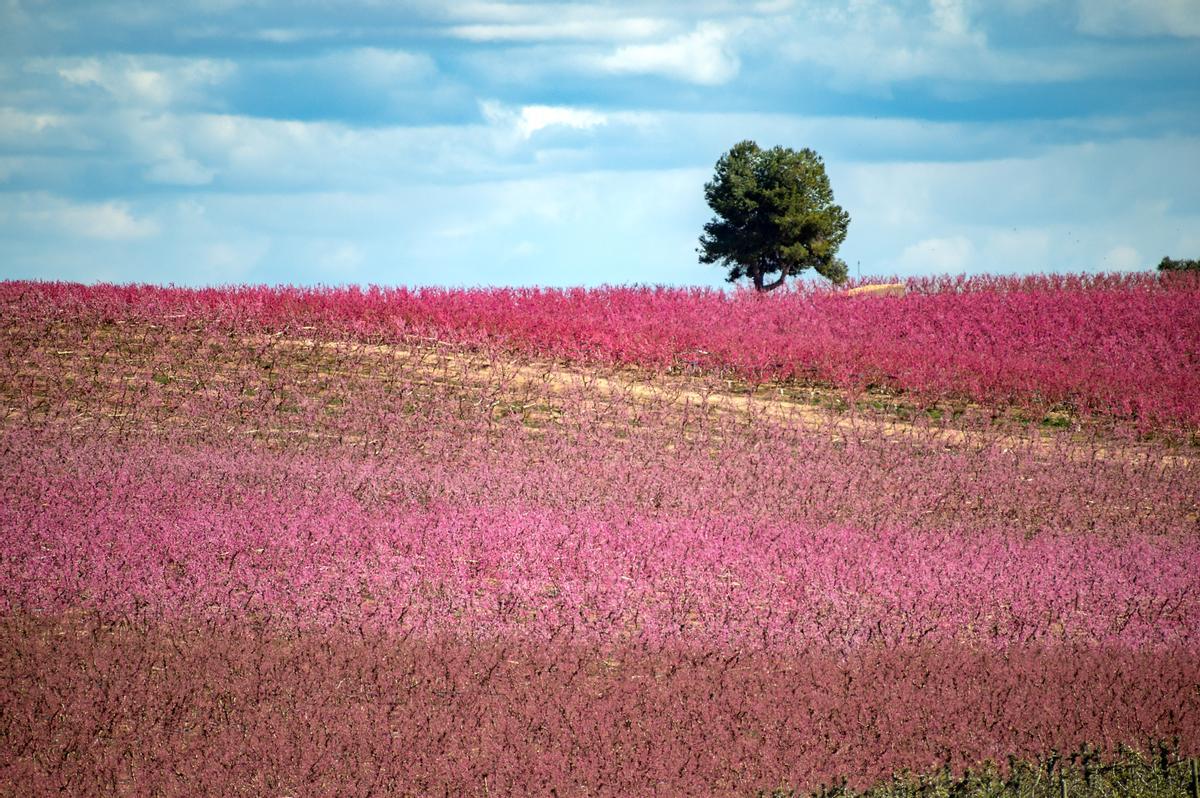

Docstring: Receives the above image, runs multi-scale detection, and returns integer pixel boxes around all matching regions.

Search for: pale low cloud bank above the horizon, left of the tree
[0,170,721,286]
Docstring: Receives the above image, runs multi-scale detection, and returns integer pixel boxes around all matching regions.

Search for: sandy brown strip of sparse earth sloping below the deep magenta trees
[0,316,1196,468]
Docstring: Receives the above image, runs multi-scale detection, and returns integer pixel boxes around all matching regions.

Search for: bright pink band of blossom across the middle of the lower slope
[0,429,1200,650]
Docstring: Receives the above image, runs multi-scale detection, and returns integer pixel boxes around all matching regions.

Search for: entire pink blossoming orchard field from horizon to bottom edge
[0,275,1200,796]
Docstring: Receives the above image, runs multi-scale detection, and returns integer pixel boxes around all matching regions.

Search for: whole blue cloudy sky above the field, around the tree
[0,0,1200,286]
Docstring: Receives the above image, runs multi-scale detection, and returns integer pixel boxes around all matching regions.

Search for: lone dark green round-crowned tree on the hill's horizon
[696,142,850,290]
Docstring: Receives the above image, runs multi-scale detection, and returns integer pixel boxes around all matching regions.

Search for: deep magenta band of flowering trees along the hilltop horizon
[0,274,1200,431]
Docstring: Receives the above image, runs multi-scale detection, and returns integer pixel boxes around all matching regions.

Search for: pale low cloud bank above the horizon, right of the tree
[830,137,1200,275]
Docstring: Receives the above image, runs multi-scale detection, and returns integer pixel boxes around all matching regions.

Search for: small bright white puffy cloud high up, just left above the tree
[596,22,740,85]
